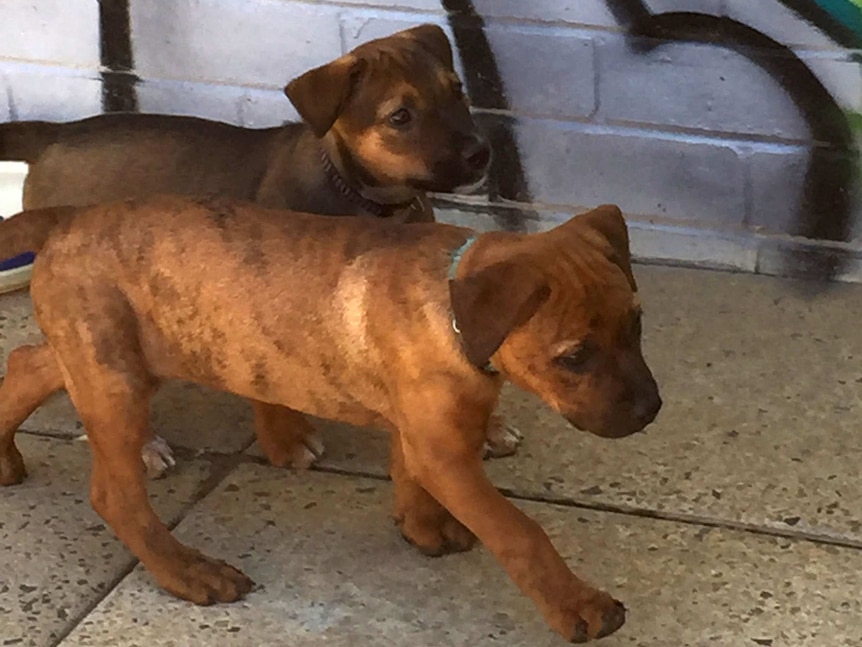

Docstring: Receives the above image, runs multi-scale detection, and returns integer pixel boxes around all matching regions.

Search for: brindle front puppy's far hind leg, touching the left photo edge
[0,343,63,485]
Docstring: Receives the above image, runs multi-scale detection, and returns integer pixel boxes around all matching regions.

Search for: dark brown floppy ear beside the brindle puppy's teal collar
[449,260,551,367]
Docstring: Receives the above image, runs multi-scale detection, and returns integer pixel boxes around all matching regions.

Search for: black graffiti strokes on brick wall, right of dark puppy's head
[442,0,862,278]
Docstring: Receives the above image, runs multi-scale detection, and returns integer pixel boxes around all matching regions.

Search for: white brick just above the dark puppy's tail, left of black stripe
[0,63,102,121]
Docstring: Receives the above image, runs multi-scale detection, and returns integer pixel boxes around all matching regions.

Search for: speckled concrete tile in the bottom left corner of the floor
[0,434,212,647]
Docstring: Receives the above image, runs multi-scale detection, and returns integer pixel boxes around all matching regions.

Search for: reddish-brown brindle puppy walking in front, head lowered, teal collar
[0,197,661,642]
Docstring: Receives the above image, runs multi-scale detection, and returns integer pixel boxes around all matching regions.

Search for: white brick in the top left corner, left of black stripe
[0,0,99,68]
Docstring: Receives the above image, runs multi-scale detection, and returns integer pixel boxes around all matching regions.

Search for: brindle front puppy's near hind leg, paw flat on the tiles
[61,346,252,604]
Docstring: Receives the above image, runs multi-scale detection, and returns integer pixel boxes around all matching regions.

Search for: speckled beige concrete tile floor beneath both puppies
[0,266,862,646]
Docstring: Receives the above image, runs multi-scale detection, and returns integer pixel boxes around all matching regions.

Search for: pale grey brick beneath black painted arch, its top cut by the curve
[596,35,809,139]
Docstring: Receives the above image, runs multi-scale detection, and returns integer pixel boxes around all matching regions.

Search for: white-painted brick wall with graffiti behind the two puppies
[0,0,862,276]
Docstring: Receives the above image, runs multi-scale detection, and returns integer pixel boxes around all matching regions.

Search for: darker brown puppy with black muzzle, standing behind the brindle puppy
[0,25,510,476]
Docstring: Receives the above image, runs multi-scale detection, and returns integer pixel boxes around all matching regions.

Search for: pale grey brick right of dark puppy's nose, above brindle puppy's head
[516,120,745,227]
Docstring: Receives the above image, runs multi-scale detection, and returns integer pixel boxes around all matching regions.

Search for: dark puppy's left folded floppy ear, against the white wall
[284,55,365,137]
